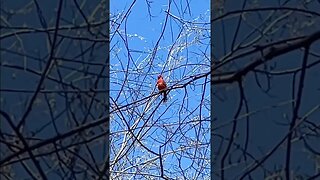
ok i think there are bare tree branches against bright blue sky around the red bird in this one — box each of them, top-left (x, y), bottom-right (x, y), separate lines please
top-left (110, 1), bottom-right (210, 179)
